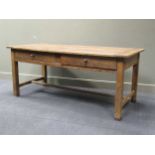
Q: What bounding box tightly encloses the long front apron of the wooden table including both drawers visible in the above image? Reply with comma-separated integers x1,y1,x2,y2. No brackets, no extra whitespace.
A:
13,51,117,71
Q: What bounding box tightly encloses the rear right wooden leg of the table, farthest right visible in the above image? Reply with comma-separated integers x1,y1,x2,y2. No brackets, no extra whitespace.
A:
131,56,139,102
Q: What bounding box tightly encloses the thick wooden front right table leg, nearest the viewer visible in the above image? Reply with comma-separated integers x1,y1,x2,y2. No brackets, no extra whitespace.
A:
114,62,124,120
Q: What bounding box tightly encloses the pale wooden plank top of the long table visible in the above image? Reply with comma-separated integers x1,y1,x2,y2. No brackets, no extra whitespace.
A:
8,44,144,58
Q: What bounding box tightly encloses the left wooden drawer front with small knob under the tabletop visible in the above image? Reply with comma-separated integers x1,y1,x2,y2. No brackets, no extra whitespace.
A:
15,52,61,66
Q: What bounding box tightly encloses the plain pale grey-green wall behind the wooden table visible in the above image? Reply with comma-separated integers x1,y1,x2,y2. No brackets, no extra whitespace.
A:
0,19,155,92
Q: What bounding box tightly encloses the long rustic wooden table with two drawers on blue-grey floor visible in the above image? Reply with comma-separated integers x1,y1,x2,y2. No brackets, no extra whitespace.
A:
8,44,144,120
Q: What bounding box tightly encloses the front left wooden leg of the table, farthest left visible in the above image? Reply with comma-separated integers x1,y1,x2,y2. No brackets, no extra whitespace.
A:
11,52,20,96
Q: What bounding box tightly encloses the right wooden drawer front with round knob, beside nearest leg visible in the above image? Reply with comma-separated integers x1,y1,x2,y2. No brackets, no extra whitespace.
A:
61,55,116,70
